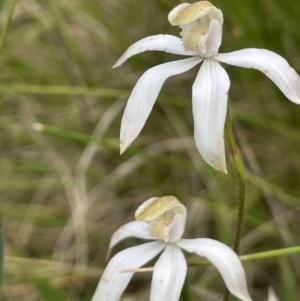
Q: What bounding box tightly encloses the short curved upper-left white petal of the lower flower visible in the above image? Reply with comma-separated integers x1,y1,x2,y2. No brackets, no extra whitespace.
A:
107,221,153,257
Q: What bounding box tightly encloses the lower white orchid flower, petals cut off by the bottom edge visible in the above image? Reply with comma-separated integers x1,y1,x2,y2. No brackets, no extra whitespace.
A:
92,196,252,301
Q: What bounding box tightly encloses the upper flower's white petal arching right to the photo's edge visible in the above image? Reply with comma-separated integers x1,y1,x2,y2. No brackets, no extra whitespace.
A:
214,48,300,104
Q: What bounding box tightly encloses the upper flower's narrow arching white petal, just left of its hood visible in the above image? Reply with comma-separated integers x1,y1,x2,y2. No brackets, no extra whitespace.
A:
113,34,198,68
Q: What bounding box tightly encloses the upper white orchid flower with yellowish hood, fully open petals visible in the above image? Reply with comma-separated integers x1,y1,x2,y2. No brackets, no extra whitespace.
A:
114,1,300,173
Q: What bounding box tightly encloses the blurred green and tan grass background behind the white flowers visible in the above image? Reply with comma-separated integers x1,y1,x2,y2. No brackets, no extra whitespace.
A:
0,0,300,301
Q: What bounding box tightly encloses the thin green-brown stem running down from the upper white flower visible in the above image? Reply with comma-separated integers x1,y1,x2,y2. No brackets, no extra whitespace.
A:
224,107,246,301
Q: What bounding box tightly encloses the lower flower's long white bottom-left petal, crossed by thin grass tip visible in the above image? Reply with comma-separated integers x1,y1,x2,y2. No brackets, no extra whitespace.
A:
92,241,165,301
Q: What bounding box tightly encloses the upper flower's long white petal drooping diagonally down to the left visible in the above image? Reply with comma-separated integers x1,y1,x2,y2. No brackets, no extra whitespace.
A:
120,57,202,154
